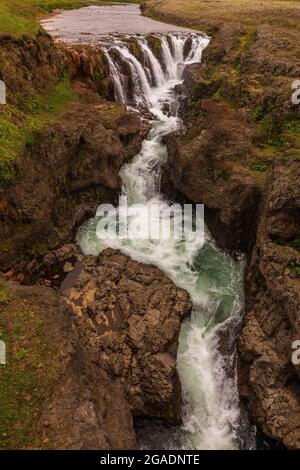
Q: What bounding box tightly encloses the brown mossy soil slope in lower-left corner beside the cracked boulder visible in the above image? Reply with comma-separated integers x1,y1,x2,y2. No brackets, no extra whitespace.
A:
0,279,135,450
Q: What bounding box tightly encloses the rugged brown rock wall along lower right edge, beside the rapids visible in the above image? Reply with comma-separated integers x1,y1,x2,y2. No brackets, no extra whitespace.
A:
239,163,300,449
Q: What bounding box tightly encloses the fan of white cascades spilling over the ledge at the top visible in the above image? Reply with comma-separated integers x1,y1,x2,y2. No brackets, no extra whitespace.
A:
104,33,208,109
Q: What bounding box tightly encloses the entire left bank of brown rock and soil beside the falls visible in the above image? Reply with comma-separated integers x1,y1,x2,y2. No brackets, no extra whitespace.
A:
0,20,191,449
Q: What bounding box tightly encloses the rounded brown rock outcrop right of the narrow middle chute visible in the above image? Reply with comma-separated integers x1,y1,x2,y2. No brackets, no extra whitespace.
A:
163,95,260,255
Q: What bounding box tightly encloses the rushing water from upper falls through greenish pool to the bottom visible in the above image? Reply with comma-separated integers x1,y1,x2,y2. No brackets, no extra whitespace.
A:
44,4,253,449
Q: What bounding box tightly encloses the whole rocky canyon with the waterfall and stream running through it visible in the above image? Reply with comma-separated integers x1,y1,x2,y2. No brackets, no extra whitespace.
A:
0,1,300,450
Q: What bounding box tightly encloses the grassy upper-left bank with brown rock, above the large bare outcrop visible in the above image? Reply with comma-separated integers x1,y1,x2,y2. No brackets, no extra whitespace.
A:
0,0,143,190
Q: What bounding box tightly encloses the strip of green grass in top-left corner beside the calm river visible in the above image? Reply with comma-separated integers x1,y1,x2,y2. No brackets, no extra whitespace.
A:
0,0,141,37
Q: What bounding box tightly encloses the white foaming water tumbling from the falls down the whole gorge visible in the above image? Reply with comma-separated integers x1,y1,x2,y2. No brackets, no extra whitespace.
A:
77,33,251,449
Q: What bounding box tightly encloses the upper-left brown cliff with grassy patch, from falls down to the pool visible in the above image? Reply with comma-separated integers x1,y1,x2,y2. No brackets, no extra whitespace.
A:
0,33,148,272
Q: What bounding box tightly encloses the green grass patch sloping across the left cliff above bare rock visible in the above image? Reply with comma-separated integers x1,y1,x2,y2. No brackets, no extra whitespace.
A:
0,75,78,190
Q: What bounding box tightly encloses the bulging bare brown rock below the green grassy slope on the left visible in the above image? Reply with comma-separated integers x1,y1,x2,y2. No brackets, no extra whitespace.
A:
0,91,147,270
